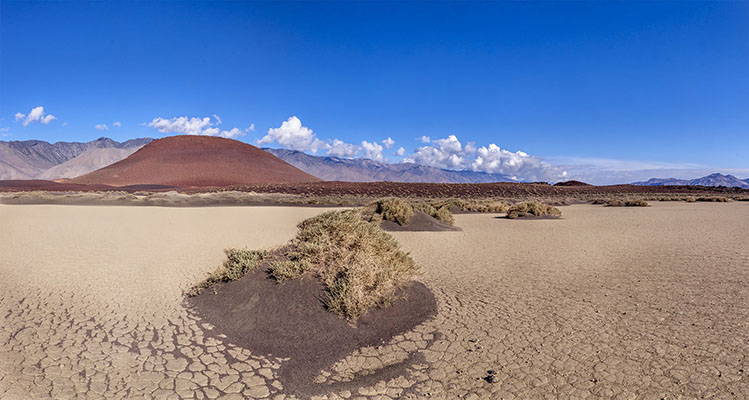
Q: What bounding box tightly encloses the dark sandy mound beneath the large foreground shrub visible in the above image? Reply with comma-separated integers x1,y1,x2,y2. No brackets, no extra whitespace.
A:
187,269,437,394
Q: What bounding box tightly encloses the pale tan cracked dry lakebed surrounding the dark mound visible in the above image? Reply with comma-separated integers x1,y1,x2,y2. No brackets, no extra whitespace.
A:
0,202,749,399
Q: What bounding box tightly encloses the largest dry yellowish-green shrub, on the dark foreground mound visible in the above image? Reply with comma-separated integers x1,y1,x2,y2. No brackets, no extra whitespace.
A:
284,210,418,320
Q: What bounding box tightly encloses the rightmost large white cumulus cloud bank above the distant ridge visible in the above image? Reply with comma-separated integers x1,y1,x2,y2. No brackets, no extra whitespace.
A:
403,135,567,181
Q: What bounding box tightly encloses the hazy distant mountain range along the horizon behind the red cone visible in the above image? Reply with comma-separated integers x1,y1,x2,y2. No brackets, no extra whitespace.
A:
0,137,749,189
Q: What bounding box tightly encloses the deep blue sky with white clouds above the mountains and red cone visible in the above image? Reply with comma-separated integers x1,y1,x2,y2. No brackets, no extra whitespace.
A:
0,0,749,183
